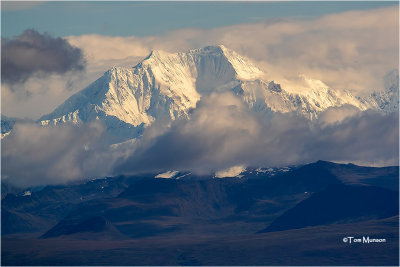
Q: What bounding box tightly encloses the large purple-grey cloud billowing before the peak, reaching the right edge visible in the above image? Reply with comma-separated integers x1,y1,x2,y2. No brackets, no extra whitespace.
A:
115,93,399,176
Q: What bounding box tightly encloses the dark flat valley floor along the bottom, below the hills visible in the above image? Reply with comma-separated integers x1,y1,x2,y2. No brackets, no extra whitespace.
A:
2,216,399,266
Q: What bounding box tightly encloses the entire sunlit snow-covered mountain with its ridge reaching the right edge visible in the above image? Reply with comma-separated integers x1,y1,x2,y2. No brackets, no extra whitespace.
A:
7,45,398,141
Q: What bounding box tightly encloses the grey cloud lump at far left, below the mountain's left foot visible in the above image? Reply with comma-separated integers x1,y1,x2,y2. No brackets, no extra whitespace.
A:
1,123,108,187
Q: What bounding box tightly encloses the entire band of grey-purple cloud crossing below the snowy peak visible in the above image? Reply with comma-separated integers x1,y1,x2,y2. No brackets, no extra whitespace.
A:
2,93,399,186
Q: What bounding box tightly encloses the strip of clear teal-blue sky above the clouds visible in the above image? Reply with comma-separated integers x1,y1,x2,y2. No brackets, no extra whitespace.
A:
1,1,398,37
